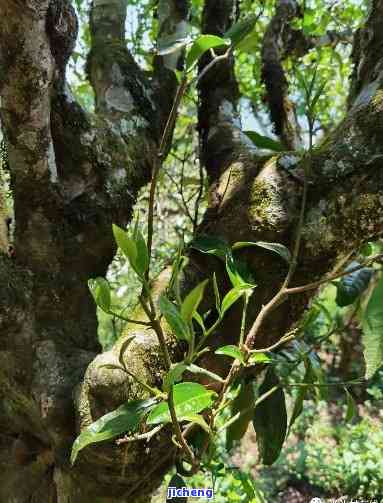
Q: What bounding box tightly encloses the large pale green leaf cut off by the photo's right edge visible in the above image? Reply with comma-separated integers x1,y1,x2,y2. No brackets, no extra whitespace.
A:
362,276,383,379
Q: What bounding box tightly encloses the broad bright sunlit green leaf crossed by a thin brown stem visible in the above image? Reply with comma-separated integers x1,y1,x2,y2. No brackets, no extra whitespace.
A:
146,382,216,424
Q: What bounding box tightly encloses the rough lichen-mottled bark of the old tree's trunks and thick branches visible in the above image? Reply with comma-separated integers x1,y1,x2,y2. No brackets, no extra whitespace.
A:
0,0,383,503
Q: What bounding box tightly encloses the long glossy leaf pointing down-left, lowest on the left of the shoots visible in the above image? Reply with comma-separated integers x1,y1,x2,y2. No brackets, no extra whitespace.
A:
71,398,157,465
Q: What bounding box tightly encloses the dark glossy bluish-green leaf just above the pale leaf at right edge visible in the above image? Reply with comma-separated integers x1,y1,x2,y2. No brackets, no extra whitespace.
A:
336,261,374,307
